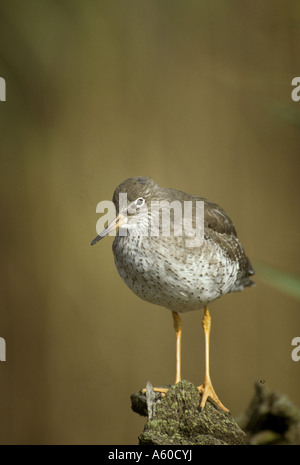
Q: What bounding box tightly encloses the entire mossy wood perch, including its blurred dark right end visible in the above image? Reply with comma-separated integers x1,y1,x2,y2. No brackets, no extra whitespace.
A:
131,381,300,445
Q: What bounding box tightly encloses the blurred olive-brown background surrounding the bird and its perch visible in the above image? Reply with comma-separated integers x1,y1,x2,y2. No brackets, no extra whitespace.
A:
0,0,300,444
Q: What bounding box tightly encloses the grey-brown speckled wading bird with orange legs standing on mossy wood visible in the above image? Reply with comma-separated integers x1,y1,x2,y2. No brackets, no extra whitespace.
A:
91,176,255,413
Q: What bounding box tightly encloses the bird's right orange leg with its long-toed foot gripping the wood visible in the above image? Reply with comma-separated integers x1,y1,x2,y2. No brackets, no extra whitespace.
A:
198,307,229,412
